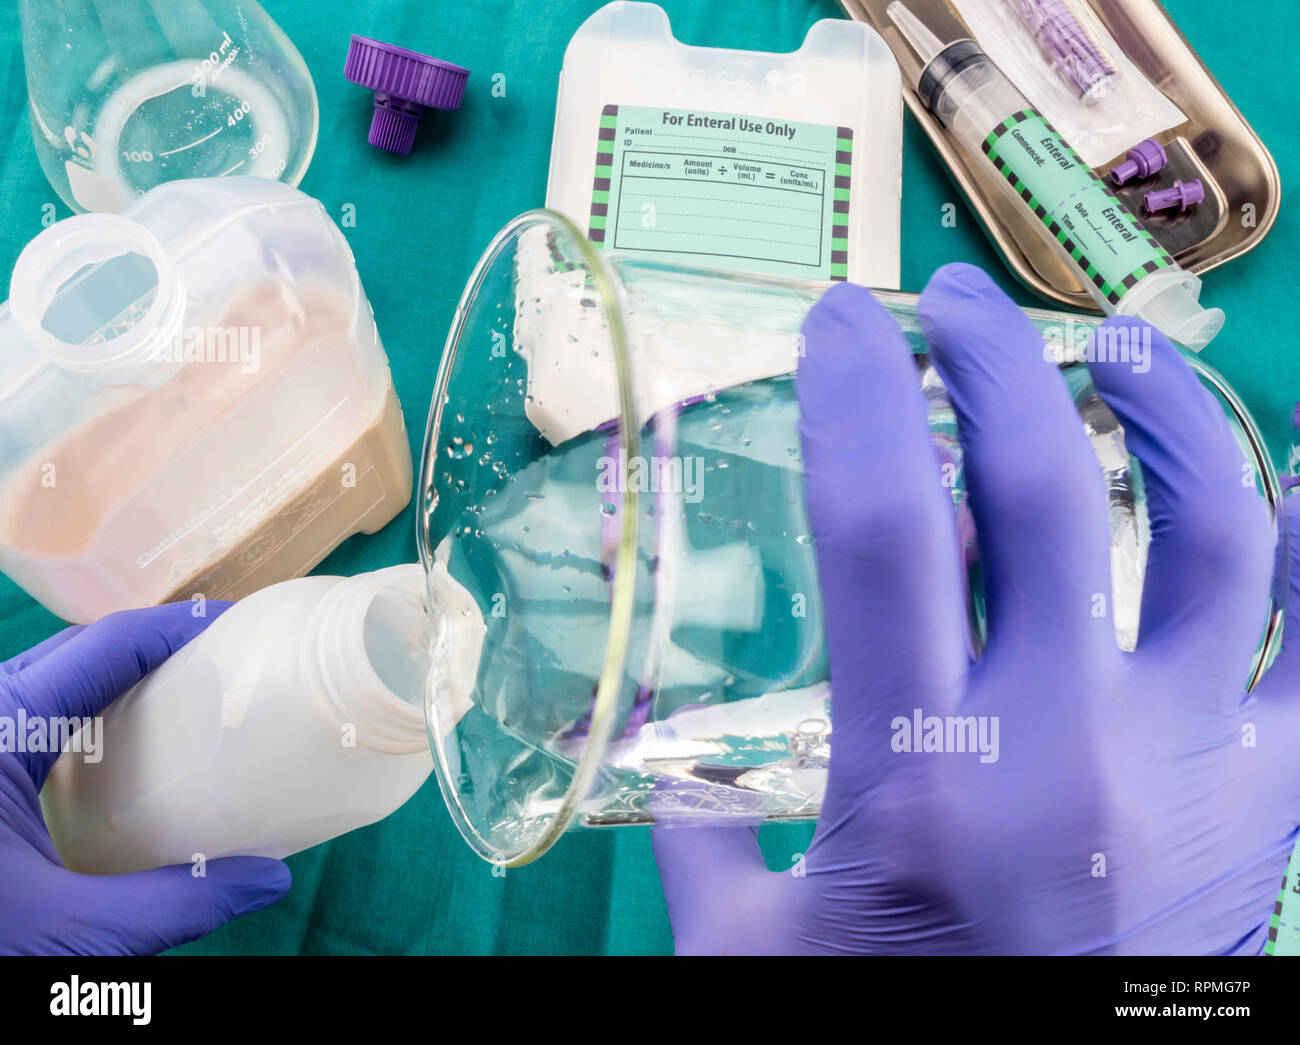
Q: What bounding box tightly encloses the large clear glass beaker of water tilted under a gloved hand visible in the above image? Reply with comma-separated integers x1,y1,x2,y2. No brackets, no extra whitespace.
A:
419,211,1284,866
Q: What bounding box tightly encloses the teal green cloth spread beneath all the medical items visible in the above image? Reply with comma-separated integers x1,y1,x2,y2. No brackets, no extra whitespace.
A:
0,0,1300,954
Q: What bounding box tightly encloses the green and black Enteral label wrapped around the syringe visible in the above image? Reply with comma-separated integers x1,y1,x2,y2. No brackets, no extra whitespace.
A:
983,109,1174,304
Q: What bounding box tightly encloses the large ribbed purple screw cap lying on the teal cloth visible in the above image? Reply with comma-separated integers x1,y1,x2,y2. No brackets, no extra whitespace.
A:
343,32,469,156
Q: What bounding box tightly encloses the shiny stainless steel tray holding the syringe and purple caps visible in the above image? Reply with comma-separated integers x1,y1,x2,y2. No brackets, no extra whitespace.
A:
840,0,1282,312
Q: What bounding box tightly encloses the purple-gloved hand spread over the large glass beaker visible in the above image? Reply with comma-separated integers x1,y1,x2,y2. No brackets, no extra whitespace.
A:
654,265,1300,954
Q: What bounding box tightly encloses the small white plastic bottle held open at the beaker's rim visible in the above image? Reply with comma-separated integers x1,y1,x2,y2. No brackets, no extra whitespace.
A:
42,564,484,875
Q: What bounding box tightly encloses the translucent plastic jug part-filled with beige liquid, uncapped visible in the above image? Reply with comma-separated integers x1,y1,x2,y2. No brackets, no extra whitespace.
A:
0,178,412,621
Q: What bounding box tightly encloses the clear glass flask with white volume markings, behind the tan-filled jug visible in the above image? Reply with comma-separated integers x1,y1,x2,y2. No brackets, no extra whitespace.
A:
18,0,320,213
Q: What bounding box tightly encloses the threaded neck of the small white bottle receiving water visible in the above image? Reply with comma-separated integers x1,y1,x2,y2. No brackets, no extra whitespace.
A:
303,564,432,754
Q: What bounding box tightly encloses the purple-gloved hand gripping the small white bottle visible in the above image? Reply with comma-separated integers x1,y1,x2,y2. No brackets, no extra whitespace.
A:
0,602,290,954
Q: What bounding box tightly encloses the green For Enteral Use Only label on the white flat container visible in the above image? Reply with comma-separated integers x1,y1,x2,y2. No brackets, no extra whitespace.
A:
588,105,853,279
